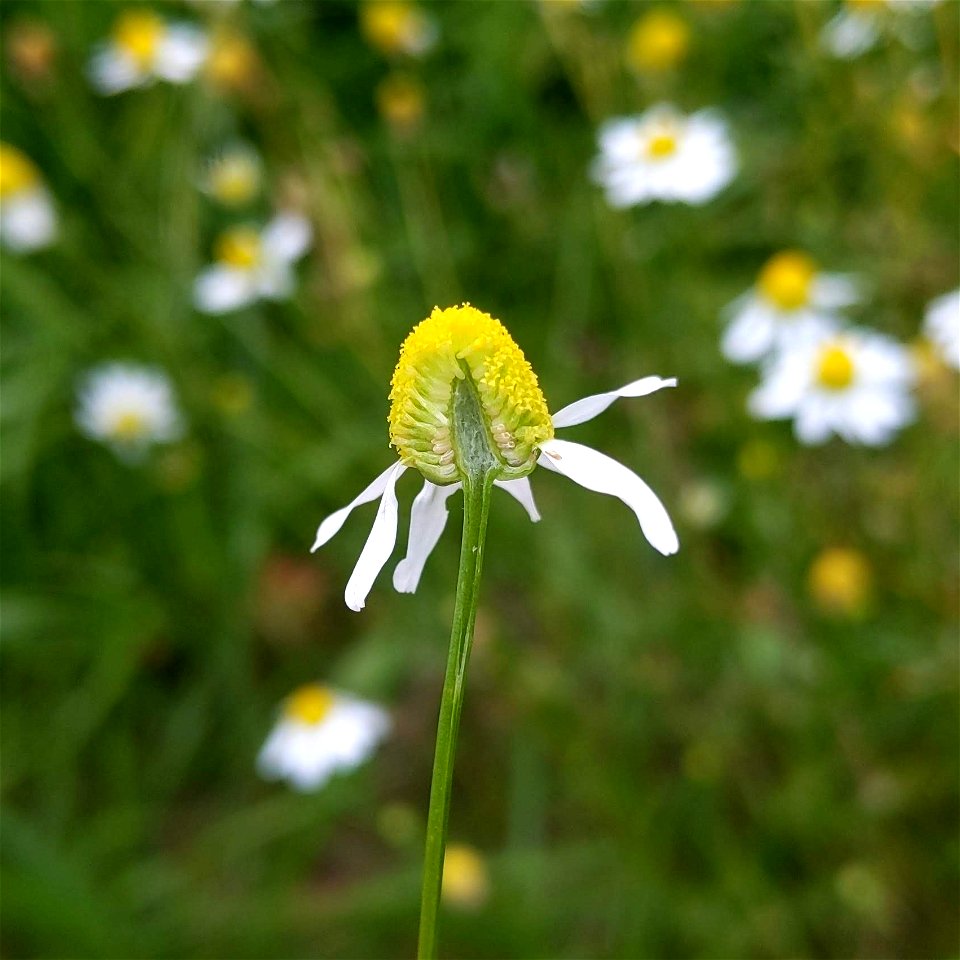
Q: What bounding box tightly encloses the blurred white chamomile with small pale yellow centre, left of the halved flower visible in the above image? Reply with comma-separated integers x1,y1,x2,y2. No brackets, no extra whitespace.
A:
76,363,183,459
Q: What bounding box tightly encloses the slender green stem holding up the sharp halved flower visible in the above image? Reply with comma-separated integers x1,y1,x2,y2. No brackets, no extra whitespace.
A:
417,469,496,960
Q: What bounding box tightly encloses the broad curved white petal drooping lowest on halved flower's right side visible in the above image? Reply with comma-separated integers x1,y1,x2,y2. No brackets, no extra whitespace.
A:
538,439,680,556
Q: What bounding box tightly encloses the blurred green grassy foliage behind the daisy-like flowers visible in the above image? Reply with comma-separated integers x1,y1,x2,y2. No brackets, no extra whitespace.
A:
0,0,958,957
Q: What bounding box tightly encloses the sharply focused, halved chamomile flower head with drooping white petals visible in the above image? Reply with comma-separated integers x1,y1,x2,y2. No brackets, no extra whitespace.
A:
313,304,679,610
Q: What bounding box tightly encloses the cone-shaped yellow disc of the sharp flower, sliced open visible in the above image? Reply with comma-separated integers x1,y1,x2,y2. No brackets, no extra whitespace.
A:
390,304,553,484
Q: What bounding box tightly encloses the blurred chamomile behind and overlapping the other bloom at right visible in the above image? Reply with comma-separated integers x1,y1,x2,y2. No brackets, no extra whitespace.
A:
720,250,860,363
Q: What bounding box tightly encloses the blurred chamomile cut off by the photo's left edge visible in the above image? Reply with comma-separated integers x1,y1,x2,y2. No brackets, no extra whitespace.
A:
0,143,57,253
